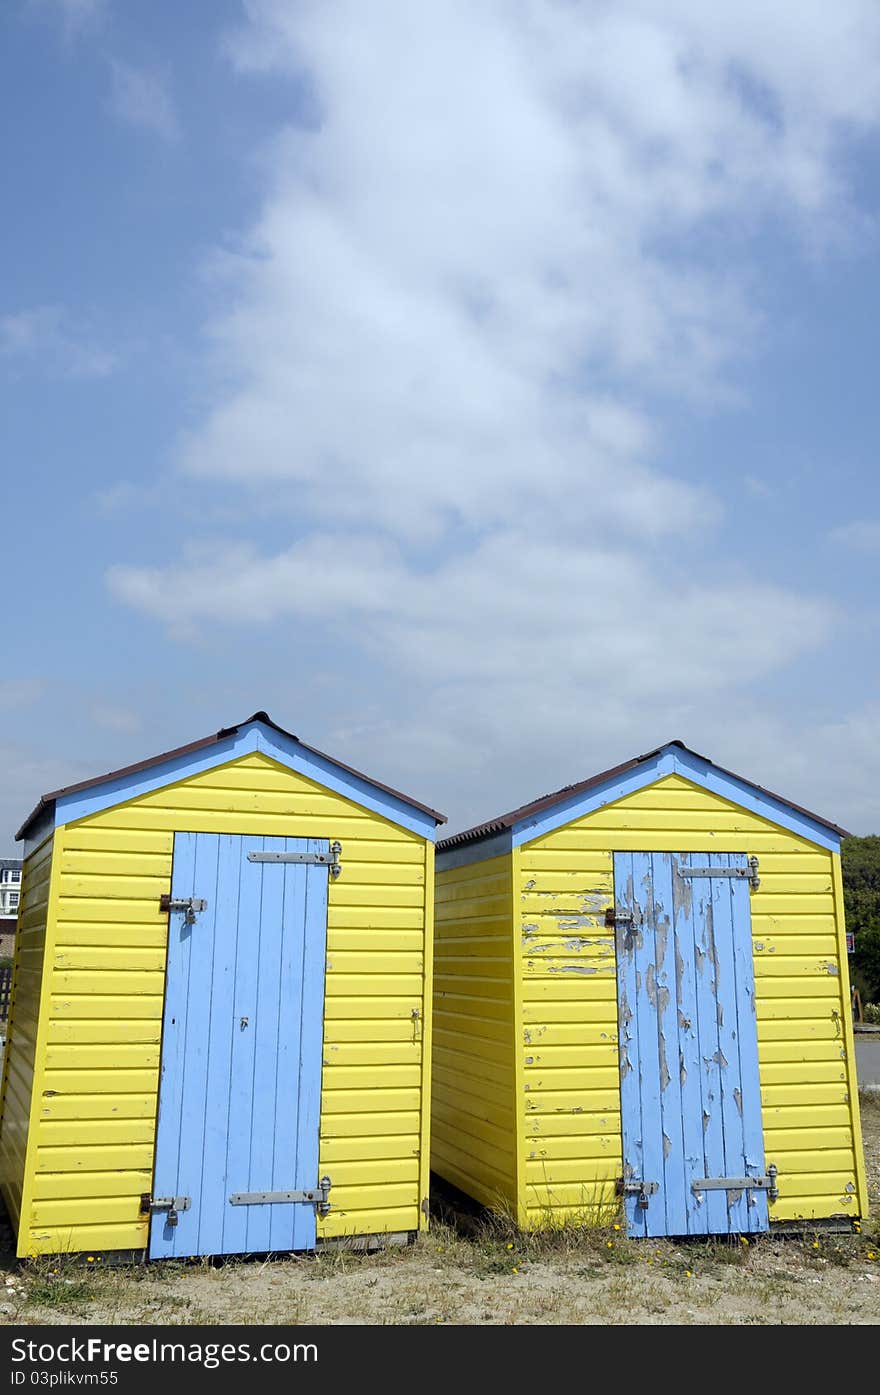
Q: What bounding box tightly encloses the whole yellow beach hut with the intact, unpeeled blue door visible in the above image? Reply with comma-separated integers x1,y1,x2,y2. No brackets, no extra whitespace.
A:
0,711,443,1258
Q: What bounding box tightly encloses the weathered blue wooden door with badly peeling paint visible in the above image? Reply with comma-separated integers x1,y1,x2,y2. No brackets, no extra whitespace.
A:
614,852,768,1236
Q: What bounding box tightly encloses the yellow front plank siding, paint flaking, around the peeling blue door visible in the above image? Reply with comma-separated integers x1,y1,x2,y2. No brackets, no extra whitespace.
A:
517,776,867,1223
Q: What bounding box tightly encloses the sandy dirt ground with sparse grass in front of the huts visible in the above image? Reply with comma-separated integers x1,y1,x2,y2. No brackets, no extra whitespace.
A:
0,1094,880,1325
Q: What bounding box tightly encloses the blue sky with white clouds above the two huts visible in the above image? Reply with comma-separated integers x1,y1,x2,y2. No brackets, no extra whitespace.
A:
0,0,880,854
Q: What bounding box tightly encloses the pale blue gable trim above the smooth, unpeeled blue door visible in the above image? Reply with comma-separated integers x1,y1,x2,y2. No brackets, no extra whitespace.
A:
54,721,437,843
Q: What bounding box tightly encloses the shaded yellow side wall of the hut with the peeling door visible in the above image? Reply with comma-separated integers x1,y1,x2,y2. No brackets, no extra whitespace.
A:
431,857,517,1205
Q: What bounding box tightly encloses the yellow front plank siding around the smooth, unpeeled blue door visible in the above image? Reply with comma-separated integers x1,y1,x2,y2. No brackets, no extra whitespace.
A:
22,753,434,1253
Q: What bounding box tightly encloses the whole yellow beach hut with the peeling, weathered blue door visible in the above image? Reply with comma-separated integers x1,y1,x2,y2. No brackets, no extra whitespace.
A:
432,741,867,1236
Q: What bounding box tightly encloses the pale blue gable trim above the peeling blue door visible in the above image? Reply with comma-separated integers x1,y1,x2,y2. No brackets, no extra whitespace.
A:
512,746,841,852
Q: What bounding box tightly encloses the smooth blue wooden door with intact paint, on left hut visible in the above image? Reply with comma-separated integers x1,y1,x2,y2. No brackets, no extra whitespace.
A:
149,833,328,1258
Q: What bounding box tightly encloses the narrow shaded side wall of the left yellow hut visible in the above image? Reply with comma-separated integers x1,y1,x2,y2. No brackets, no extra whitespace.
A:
0,837,53,1229
